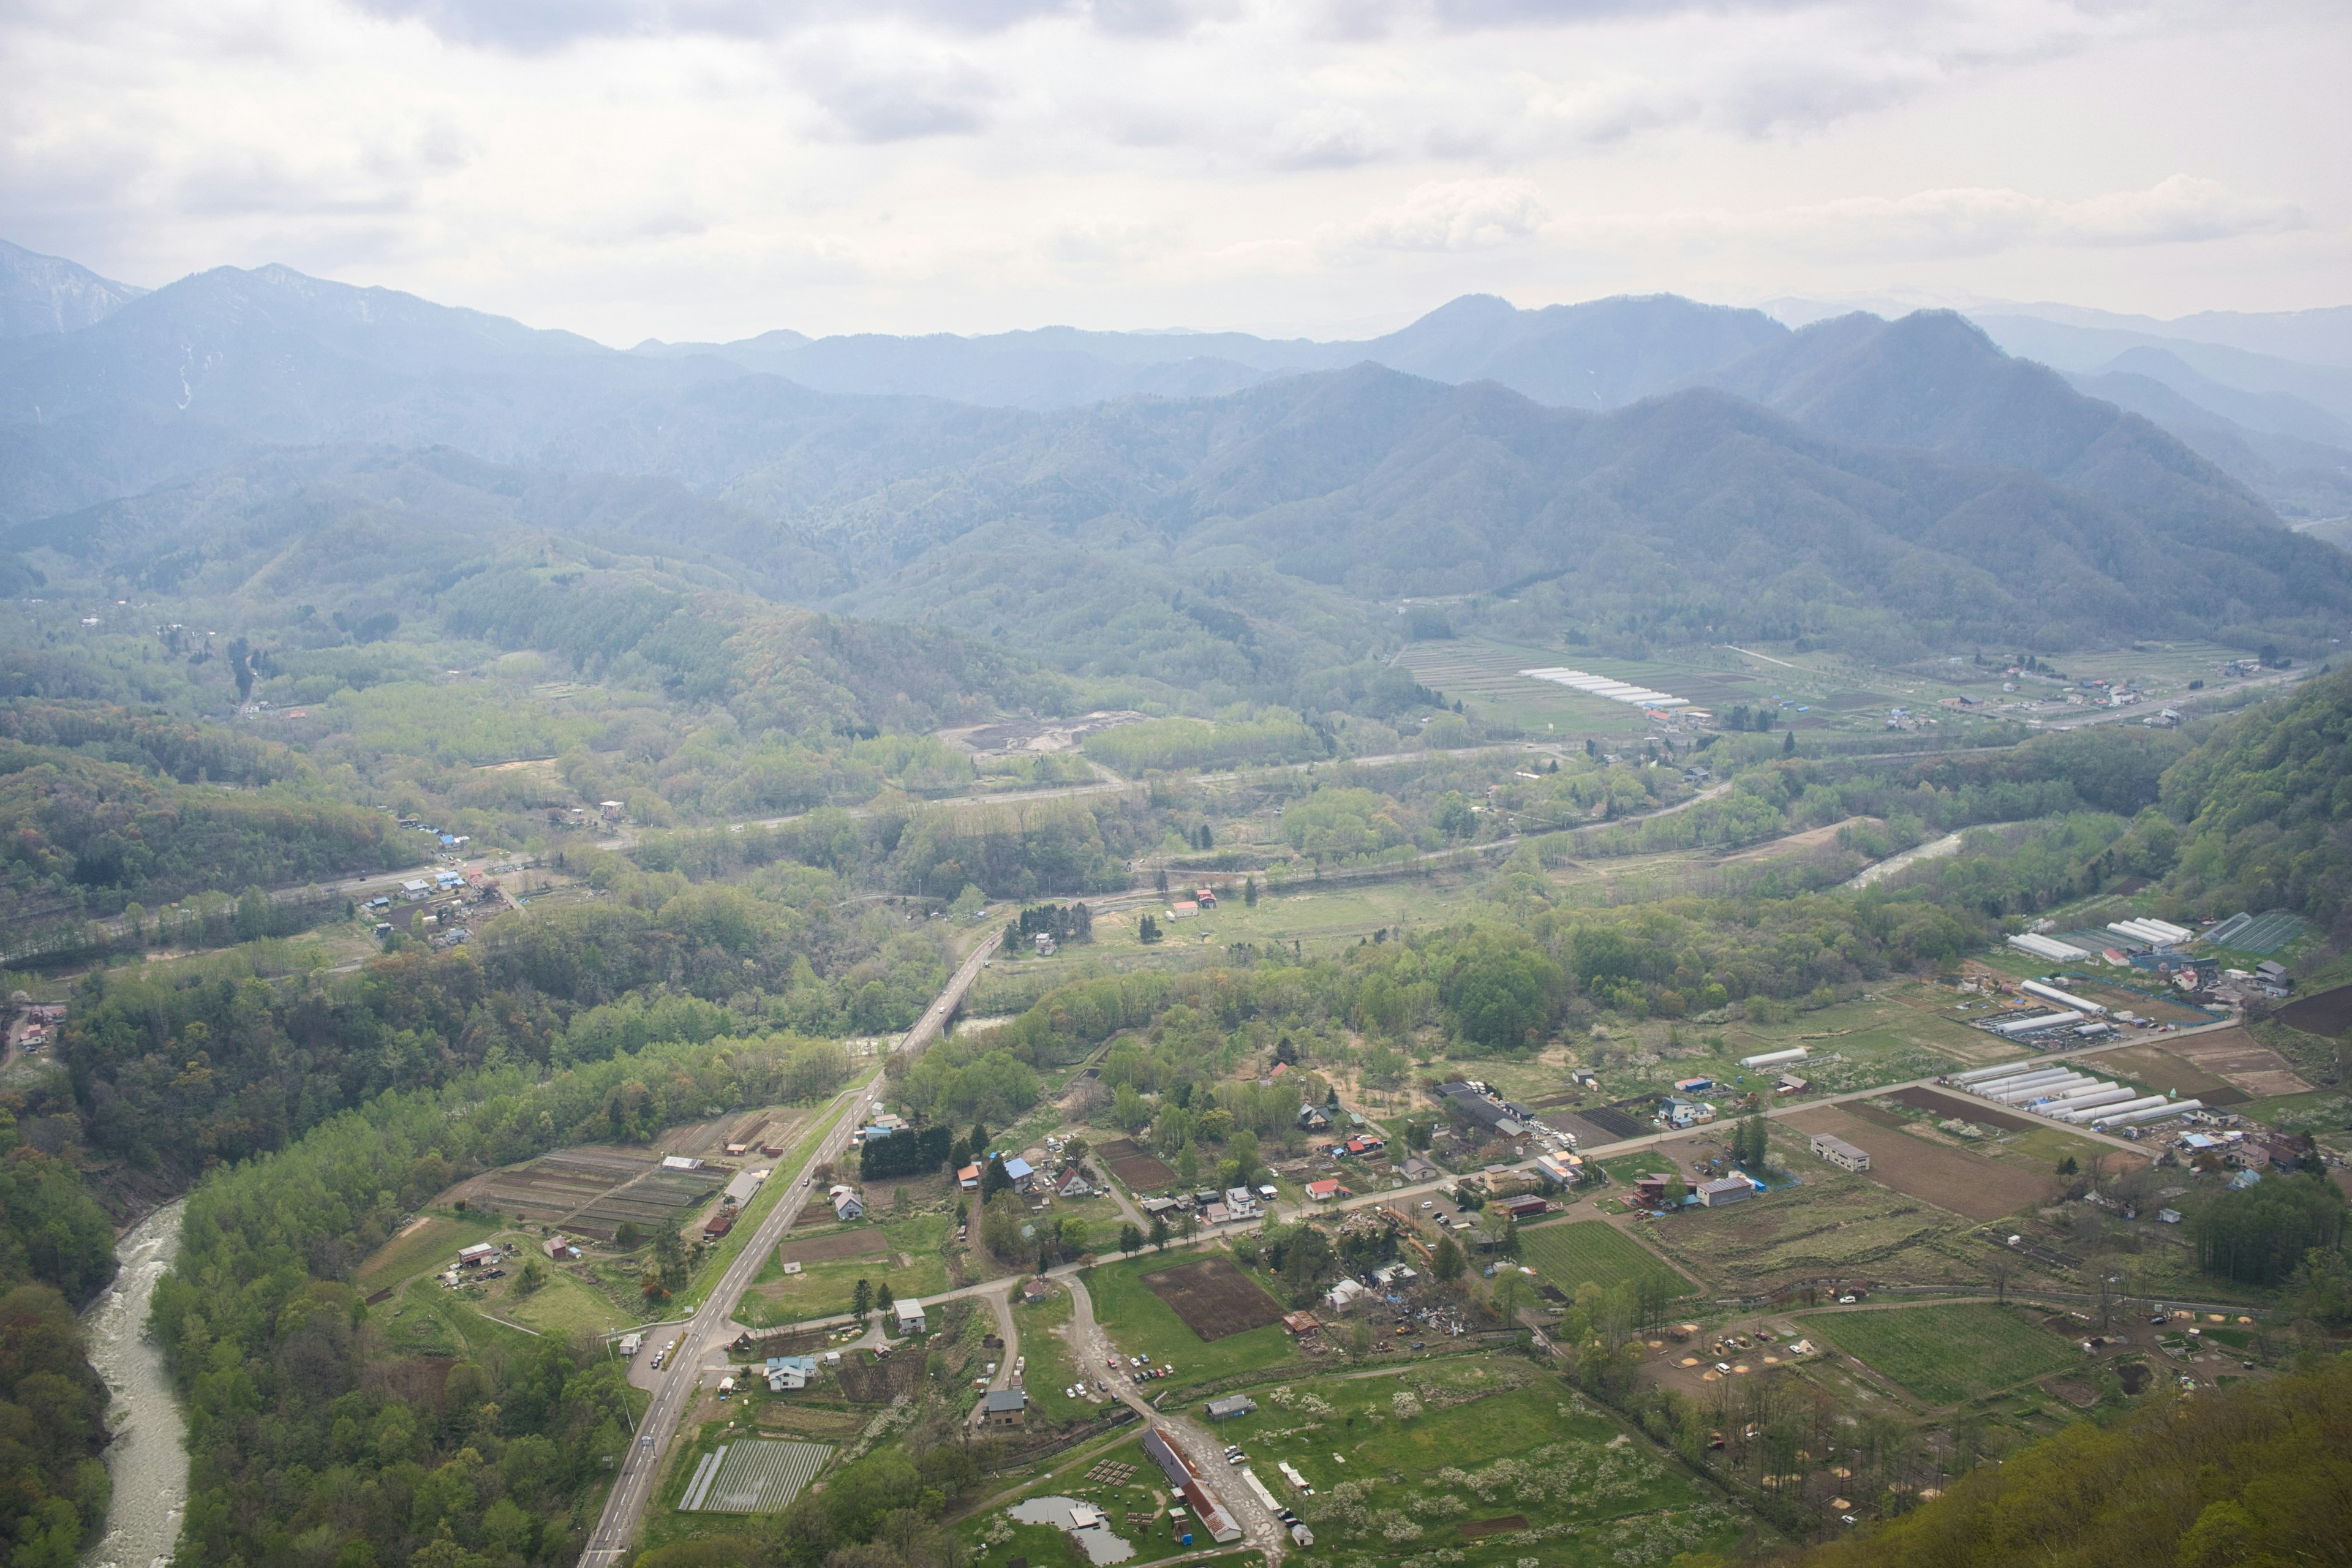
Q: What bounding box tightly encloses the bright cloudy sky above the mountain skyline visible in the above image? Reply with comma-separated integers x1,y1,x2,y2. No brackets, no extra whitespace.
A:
0,0,2352,345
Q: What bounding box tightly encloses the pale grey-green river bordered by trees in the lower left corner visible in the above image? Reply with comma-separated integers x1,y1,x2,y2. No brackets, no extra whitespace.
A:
82,1201,188,1568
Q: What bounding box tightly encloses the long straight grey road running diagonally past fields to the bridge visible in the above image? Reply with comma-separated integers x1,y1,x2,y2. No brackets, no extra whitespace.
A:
581,929,997,1568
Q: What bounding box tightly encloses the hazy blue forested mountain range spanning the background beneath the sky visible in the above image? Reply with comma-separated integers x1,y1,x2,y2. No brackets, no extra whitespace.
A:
0,242,2352,670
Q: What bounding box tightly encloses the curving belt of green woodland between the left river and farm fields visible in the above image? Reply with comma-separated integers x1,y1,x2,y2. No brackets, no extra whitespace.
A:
155,1037,846,1568
